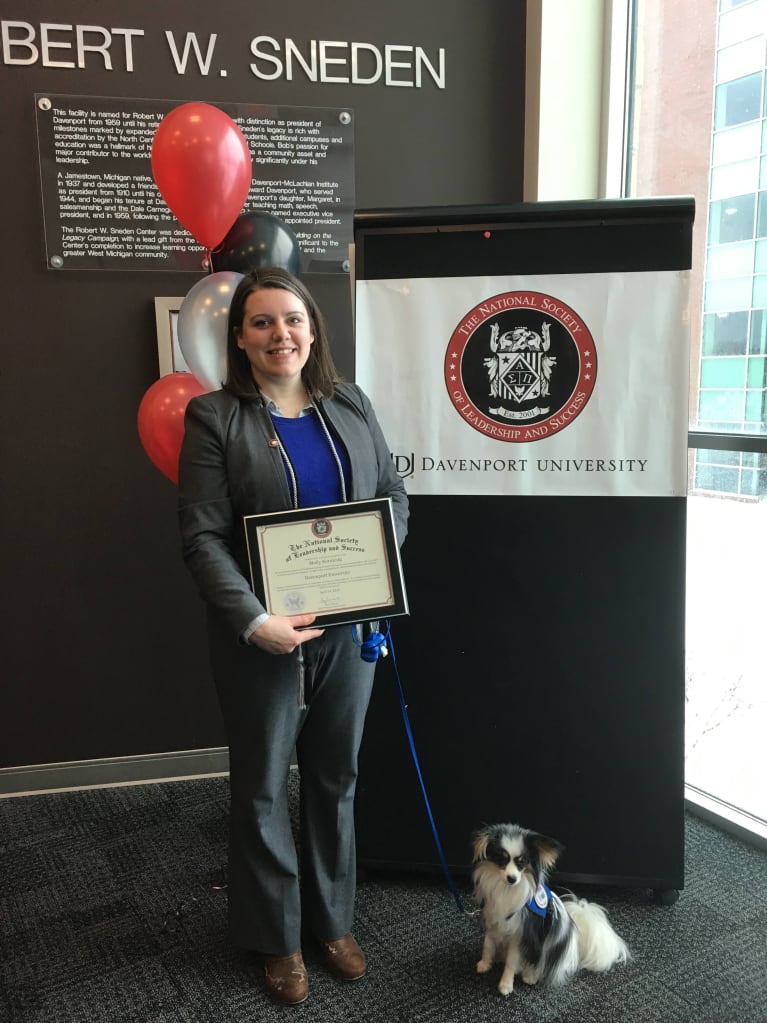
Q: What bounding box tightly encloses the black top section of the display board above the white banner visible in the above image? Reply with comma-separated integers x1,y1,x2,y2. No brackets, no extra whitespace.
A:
354,195,695,279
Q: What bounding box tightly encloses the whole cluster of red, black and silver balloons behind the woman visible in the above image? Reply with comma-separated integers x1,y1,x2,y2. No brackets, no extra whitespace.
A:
138,103,301,483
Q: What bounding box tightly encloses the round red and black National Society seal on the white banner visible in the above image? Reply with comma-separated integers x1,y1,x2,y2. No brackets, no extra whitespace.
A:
445,292,596,443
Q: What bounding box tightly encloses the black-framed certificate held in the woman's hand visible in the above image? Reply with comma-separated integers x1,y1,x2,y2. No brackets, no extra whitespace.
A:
243,497,408,628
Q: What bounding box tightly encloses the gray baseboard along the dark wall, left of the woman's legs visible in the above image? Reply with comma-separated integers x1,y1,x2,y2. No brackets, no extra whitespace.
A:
0,747,229,798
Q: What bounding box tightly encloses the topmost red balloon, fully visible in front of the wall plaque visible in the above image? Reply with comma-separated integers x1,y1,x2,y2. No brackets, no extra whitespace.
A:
151,103,253,249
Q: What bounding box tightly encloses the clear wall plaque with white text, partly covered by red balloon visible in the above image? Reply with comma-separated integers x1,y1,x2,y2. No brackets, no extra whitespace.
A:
35,93,354,273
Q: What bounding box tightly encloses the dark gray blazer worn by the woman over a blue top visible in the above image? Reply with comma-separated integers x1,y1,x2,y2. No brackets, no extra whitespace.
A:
178,384,408,641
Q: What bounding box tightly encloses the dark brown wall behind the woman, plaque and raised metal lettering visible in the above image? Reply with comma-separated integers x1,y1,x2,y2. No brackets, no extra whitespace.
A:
0,0,525,766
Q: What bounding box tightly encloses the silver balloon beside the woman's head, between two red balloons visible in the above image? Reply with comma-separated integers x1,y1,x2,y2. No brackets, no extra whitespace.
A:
177,270,243,391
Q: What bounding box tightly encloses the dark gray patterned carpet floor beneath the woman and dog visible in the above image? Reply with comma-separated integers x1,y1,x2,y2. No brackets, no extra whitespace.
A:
0,777,767,1023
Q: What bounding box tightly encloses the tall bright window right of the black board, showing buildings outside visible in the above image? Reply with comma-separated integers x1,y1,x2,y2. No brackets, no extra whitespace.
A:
627,0,767,837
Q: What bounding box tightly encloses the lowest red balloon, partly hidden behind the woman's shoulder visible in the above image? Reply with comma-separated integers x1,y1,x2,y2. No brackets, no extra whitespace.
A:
138,373,207,483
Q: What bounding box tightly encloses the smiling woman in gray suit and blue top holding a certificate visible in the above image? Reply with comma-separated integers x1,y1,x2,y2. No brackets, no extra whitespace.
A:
179,267,407,1005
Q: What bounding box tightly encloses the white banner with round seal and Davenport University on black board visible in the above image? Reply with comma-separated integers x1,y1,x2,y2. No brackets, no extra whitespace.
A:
356,270,689,497
